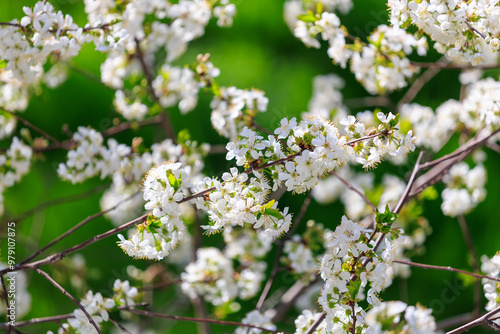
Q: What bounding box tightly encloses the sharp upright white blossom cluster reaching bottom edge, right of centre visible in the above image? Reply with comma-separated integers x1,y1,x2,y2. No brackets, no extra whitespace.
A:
318,216,398,333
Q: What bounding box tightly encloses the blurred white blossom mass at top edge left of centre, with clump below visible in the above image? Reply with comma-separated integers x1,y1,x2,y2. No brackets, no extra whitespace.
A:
85,0,236,90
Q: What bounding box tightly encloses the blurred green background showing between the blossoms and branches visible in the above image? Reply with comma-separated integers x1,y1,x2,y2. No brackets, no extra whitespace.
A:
0,0,500,333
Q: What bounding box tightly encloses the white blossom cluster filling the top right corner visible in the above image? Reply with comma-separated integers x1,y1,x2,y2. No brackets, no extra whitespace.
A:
388,0,500,65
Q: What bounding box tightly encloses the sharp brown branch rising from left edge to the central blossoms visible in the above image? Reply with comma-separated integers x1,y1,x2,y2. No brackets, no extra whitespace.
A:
0,214,148,276
